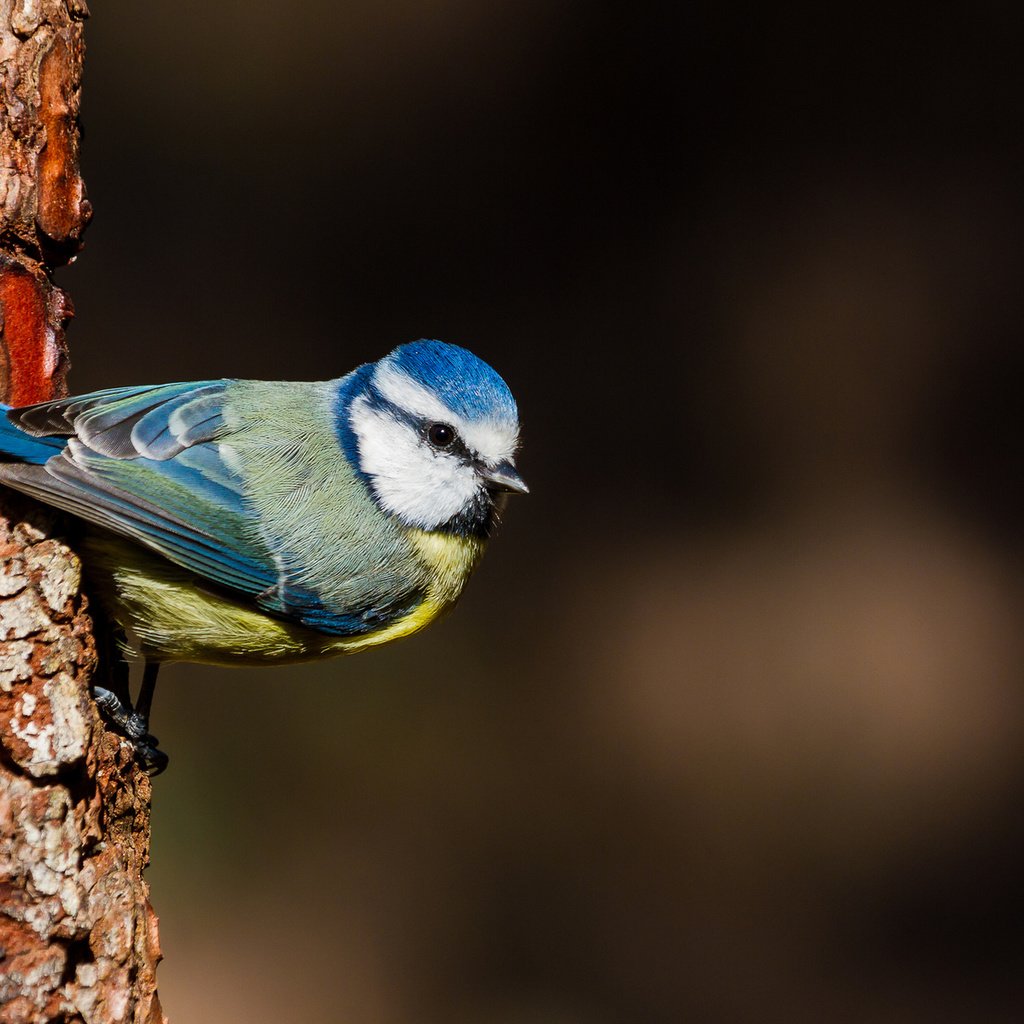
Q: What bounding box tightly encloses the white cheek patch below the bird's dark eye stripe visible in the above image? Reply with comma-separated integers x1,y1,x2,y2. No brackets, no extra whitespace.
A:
351,398,479,529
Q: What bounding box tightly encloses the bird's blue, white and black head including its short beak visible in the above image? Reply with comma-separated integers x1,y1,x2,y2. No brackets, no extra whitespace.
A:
339,341,527,537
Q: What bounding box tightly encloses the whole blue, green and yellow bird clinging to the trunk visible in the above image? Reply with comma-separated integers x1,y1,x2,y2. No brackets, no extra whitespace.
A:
0,339,528,773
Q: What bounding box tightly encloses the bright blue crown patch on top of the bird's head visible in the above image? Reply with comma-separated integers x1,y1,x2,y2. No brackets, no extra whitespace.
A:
384,340,519,424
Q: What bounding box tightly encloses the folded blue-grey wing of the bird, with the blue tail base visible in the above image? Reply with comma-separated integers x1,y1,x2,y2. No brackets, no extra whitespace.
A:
0,380,395,635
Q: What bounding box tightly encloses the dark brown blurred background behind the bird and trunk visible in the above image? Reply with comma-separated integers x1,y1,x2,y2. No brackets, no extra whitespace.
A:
60,0,1024,1024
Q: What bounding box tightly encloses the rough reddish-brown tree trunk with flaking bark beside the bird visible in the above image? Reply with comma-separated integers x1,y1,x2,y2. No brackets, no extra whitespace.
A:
0,0,164,1024
